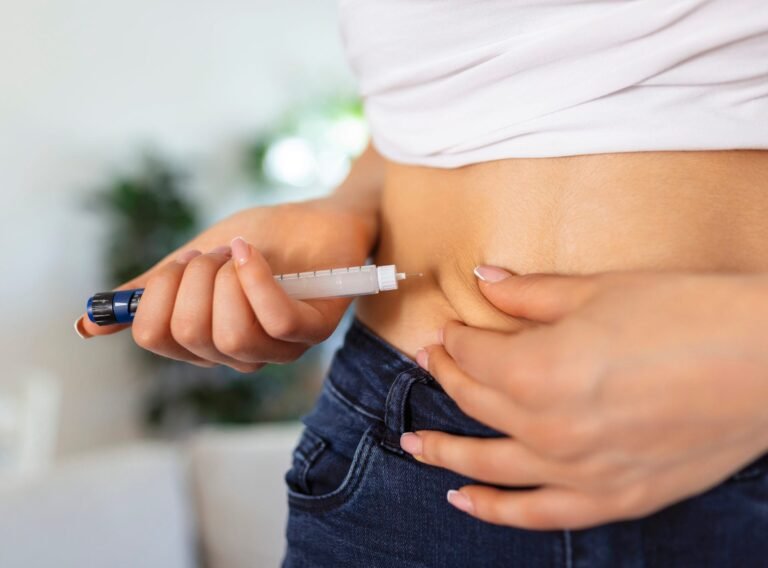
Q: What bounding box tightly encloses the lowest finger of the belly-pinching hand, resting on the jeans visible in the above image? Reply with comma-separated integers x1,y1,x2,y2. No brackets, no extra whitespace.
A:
448,485,617,530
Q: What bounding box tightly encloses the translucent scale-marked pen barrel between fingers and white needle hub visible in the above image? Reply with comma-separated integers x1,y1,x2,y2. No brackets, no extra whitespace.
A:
275,265,379,300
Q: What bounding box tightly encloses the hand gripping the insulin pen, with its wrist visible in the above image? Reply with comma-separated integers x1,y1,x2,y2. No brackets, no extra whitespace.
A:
76,197,377,372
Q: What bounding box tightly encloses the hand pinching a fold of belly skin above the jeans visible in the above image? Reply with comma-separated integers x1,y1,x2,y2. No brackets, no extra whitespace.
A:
401,267,768,529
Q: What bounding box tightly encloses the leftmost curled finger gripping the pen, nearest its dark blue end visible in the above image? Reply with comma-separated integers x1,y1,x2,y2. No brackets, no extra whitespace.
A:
132,251,213,366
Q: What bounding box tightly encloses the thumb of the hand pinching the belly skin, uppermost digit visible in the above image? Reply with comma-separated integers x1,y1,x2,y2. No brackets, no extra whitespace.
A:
474,266,596,323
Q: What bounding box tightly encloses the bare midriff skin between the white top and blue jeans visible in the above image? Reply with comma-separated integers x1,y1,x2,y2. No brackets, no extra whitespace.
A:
357,151,768,356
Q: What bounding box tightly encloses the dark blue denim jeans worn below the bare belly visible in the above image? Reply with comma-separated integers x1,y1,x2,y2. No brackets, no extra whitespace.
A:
283,321,768,568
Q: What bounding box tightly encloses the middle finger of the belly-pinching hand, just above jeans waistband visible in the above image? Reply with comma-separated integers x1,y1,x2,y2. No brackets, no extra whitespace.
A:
417,345,521,434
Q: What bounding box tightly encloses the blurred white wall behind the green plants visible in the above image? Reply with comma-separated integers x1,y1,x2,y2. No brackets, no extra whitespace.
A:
0,0,354,455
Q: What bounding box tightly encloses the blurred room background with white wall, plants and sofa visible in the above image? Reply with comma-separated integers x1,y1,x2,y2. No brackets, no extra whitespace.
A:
0,0,367,568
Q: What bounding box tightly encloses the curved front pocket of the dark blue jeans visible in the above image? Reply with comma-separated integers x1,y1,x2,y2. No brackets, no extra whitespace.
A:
285,426,376,510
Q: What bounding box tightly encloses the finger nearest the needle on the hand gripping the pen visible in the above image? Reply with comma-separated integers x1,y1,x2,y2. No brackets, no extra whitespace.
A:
232,237,348,343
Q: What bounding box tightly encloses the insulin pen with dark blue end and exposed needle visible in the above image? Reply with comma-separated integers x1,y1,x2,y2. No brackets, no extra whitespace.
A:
86,264,421,325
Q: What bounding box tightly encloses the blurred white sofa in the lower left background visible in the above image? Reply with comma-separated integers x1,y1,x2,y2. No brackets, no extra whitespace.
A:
0,424,299,568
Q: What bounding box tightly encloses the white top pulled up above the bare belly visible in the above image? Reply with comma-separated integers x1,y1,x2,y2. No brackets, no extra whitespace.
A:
340,0,768,168
